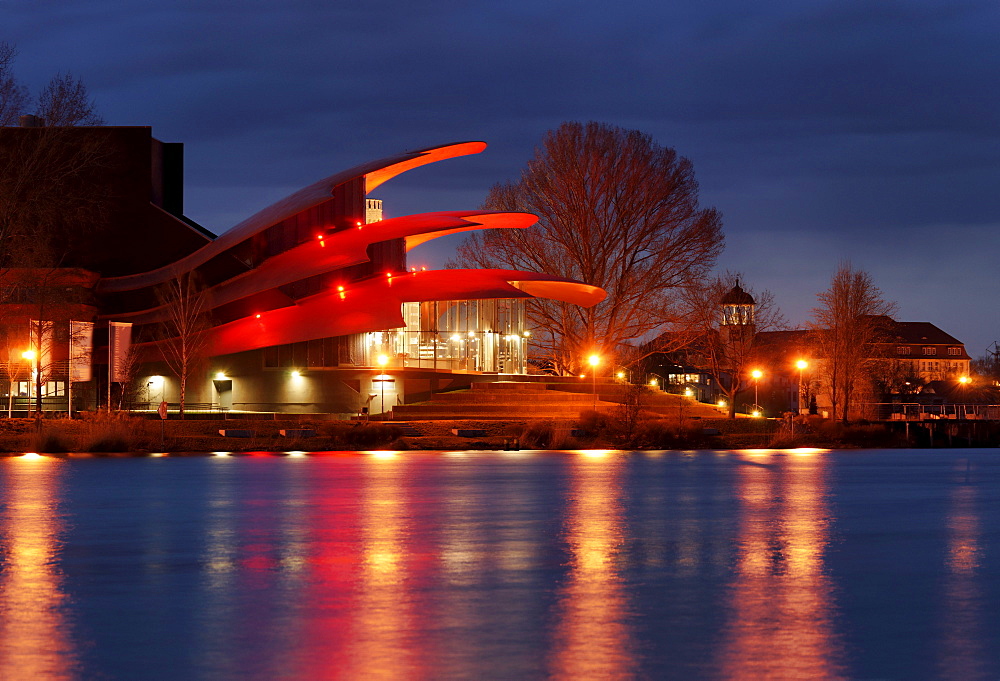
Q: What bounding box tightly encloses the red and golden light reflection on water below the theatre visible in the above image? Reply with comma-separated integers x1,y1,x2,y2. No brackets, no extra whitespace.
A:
300,453,434,679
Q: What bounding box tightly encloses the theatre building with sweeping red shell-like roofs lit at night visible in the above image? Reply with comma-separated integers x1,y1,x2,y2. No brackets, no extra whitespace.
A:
0,121,605,416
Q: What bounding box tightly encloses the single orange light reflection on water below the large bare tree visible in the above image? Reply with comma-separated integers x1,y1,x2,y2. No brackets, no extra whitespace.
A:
550,452,635,680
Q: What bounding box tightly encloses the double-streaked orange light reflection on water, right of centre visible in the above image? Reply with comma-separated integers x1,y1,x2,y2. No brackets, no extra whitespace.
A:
721,452,845,679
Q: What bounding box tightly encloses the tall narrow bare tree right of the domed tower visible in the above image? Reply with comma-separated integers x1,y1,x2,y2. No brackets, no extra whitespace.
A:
812,262,896,423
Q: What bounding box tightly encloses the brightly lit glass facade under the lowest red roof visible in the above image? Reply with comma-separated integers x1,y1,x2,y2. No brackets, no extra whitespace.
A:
364,299,528,374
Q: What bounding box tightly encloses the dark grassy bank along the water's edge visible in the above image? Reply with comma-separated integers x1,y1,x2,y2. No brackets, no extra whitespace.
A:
0,413,984,453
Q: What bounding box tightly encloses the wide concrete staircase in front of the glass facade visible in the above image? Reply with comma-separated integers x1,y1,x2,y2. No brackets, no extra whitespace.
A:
392,381,616,421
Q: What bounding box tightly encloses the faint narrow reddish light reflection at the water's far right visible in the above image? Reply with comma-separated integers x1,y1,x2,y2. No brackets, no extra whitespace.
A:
938,464,995,679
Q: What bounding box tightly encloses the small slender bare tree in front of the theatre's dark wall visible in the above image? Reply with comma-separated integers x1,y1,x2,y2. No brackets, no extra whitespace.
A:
157,273,211,419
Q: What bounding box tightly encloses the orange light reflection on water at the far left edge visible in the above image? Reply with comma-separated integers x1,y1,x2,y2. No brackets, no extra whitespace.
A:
0,456,77,679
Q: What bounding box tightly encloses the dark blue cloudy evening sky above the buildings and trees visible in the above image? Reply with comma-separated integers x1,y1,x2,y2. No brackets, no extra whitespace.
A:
0,0,1000,356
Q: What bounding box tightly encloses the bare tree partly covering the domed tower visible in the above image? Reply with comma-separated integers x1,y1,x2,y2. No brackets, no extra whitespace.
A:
683,272,786,418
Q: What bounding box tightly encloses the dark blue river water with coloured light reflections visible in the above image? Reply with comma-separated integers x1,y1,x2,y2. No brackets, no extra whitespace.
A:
0,449,1000,680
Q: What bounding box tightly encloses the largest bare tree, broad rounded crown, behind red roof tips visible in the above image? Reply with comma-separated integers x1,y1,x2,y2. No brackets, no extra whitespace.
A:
456,123,724,373
